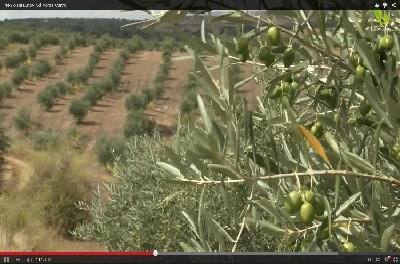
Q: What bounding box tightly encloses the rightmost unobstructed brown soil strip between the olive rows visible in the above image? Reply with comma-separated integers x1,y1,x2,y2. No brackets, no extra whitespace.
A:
145,53,193,133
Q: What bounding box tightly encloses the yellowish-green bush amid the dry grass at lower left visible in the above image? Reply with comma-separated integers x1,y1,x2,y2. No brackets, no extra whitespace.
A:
27,153,90,238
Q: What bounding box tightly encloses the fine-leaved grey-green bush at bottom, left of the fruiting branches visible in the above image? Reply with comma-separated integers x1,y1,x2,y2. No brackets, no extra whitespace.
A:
73,136,191,252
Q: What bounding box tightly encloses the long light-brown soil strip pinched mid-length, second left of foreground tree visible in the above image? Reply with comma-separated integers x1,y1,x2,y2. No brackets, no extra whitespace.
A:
79,51,161,138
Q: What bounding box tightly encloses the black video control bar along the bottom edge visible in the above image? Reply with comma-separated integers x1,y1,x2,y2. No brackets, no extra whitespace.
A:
0,253,400,264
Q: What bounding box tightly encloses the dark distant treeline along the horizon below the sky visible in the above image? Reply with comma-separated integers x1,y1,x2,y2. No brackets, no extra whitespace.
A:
0,18,169,40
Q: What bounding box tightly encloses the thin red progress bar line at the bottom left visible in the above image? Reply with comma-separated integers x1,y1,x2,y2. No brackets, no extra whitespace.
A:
0,251,154,256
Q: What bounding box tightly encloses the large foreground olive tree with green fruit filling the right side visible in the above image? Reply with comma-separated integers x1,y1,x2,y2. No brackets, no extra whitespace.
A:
76,10,400,252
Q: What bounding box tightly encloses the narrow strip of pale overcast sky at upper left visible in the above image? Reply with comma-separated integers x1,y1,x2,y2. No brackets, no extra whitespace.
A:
0,10,151,20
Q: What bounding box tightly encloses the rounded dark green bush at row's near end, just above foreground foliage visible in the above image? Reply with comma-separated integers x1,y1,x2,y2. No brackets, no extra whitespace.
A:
124,110,155,138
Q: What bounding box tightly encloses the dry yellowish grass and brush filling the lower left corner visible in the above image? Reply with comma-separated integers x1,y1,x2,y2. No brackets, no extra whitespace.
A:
0,135,105,251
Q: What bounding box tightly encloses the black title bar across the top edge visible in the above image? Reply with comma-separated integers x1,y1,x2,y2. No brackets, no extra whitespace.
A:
0,0,394,10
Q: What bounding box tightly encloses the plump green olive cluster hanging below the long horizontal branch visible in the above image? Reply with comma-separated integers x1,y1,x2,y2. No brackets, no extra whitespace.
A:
285,190,325,225
